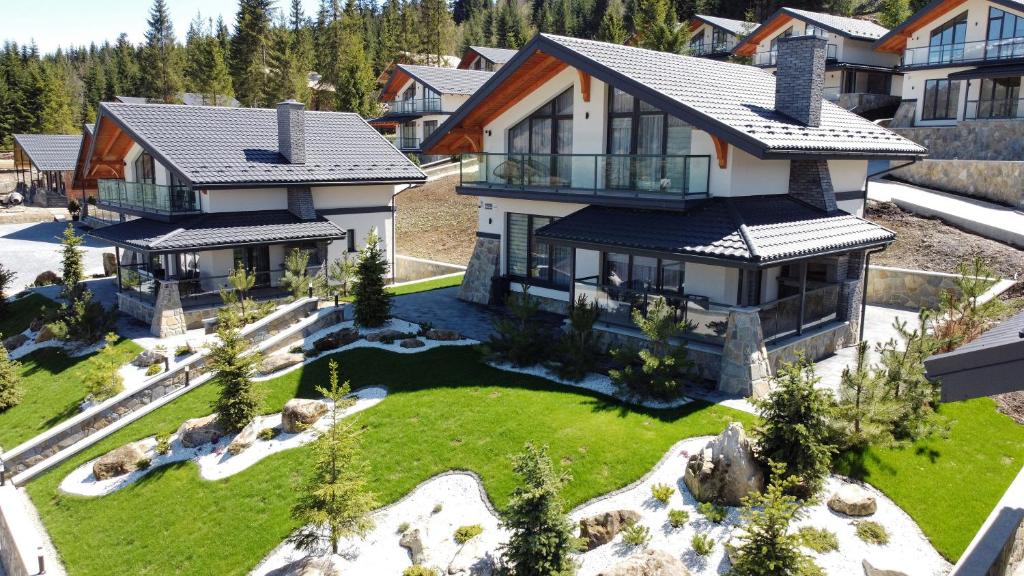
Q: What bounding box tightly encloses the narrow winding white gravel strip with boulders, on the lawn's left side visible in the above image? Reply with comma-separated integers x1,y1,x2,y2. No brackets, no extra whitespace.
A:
60,386,387,496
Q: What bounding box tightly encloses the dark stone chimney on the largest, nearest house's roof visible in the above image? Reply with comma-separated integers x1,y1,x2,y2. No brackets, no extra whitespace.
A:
775,36,828,128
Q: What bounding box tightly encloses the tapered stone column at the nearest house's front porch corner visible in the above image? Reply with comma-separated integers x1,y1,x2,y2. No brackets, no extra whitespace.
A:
718,307,771,398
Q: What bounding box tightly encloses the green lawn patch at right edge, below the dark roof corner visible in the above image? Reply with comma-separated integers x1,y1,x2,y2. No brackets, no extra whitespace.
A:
838,398,1024,562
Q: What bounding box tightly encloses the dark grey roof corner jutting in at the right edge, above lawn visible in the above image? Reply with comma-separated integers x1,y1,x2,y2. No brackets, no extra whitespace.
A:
925,313,1024,402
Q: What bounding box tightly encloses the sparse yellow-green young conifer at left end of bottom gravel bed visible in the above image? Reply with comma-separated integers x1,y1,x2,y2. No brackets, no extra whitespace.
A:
289,360,377,553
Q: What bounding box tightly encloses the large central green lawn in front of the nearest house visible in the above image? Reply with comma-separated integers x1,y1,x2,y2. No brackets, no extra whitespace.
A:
28,347,751,575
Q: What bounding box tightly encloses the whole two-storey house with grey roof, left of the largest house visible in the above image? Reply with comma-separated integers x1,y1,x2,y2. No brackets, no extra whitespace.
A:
85,100,425,336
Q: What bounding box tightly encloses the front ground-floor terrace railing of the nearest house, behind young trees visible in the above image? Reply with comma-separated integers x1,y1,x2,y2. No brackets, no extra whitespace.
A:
575,276,734,344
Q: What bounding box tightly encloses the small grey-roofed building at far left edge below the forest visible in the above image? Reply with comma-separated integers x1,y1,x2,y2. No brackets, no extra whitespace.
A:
14,134,82,207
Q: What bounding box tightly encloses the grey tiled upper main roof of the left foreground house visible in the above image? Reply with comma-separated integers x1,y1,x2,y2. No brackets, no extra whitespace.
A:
90,102,426,188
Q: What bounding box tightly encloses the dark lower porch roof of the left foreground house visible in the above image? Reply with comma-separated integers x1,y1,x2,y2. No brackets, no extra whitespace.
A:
89,210,345,252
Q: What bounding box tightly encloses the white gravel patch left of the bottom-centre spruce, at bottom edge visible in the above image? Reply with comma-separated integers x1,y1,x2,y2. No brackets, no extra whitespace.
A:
251,472,508,576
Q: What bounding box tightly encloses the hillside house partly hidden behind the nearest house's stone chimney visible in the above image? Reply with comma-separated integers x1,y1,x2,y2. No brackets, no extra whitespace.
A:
733,8,902,119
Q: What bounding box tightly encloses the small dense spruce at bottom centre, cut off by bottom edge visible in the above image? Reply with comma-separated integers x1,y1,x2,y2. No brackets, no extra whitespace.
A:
502,444,575,576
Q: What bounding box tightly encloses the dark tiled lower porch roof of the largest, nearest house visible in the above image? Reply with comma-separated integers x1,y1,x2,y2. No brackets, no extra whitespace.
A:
537,195,896,266
